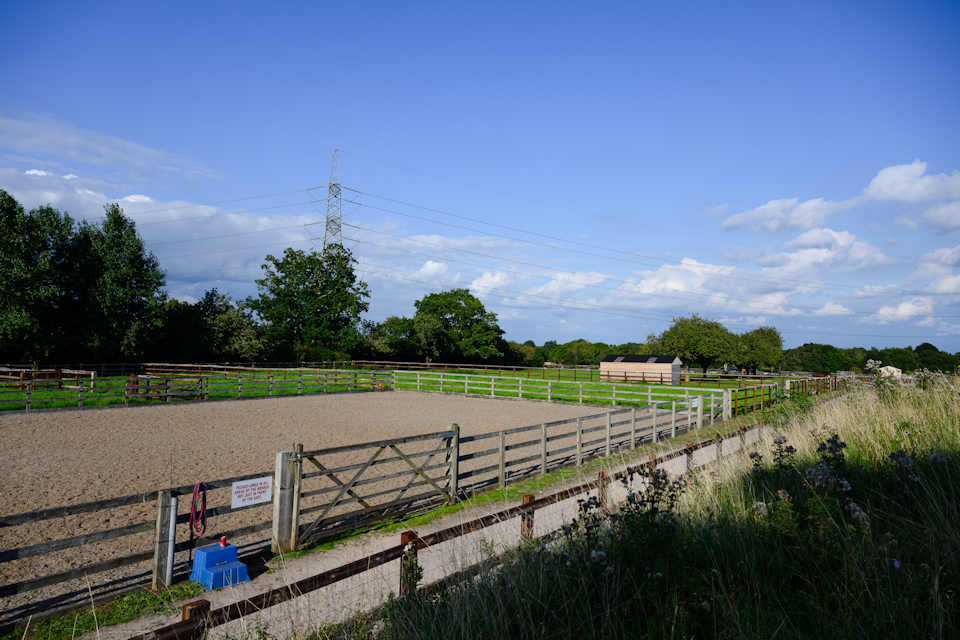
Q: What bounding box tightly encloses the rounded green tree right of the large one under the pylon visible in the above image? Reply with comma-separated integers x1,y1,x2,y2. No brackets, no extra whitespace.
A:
413,289,506,362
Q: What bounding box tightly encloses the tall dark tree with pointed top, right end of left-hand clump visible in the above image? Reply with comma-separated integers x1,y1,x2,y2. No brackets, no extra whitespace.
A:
73,203,164,361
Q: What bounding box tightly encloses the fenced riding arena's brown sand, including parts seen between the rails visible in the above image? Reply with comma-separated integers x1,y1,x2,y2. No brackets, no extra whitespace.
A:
0,391,604,623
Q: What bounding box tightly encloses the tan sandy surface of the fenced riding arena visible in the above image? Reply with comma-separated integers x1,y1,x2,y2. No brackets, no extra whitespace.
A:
0,391,602,618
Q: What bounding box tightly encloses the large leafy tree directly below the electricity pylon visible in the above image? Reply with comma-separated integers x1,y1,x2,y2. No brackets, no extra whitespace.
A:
246,244,370,362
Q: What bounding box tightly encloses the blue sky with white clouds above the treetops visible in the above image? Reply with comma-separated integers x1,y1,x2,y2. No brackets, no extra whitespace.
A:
0,2,960,351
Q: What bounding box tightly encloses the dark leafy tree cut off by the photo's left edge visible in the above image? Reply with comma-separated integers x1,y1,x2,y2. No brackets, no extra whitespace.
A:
0,190,74,363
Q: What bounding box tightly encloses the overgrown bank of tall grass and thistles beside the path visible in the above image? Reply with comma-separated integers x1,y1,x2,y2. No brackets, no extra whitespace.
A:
318,377,960,640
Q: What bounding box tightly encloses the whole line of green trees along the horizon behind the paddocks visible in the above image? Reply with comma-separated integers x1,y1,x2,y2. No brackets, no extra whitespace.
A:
0,190,958,372
